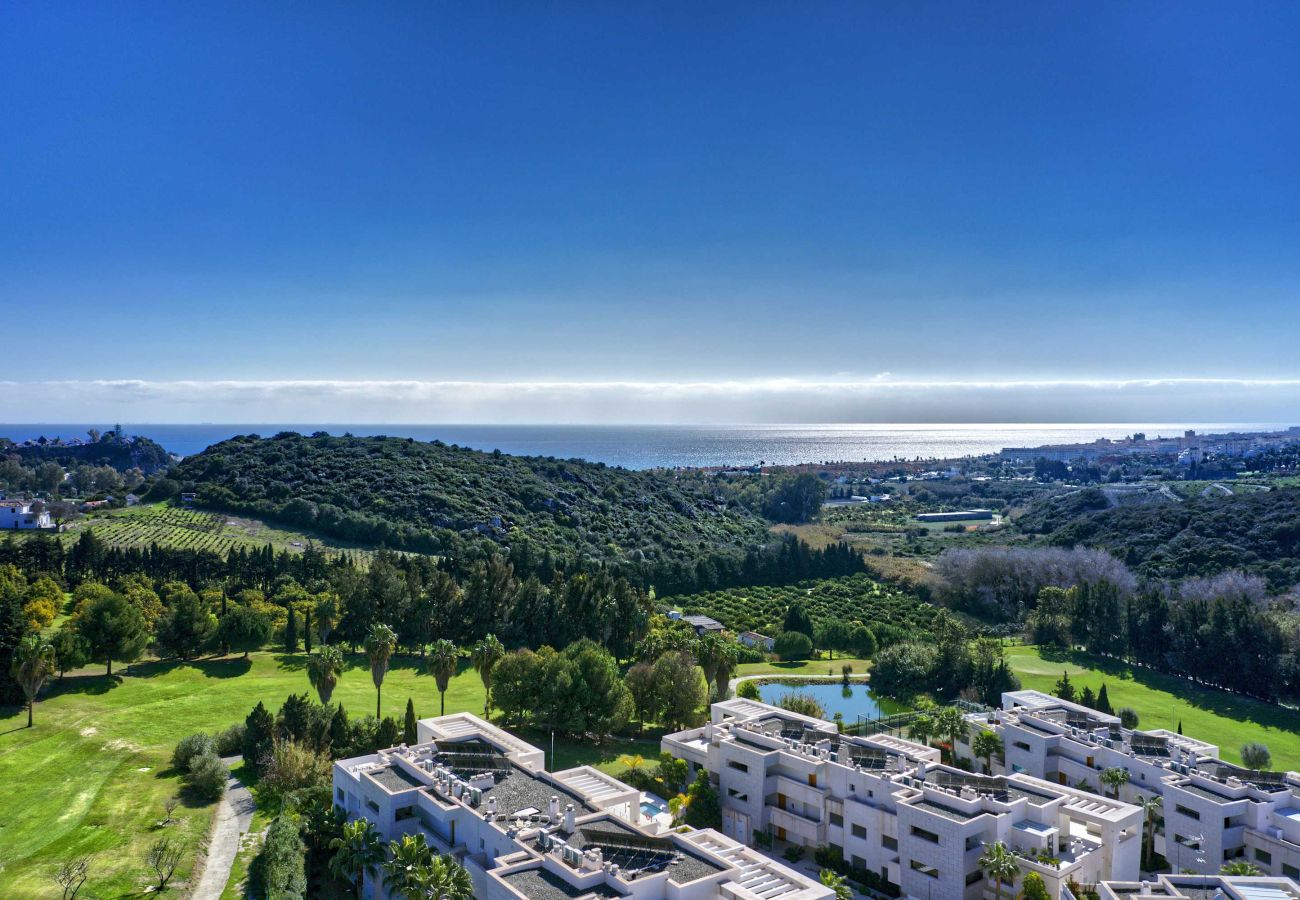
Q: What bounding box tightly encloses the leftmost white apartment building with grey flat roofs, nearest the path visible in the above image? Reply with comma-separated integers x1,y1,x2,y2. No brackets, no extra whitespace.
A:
334,713,835,900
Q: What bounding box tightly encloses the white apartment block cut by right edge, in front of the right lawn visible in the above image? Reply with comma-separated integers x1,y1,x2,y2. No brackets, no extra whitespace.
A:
958,691,1300,878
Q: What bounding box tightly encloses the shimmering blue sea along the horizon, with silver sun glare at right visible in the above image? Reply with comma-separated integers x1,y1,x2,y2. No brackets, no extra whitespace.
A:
0,423,1292,468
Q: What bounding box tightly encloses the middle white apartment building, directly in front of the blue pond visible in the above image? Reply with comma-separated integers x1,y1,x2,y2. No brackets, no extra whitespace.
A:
663,698,1143,900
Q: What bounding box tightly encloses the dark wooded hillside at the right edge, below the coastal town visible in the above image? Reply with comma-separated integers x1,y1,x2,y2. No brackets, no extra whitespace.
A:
1019,489,1300,590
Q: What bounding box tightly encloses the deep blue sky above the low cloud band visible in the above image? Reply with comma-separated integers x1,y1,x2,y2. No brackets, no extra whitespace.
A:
0,3,1300,420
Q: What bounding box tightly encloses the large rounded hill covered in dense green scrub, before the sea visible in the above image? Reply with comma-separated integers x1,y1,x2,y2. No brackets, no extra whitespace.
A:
170,433,766,566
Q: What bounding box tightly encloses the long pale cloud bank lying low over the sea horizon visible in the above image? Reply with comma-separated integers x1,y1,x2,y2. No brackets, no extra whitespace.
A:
0,376,1300,424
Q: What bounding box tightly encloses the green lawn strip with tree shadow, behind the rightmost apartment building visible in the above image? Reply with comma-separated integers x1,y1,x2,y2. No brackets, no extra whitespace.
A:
1008,646,1300,770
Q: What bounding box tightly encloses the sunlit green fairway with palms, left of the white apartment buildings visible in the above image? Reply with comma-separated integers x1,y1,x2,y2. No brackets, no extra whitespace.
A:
0,653,658,897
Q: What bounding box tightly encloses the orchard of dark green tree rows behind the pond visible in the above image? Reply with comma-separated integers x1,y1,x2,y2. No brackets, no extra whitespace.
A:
672,575,935,645
